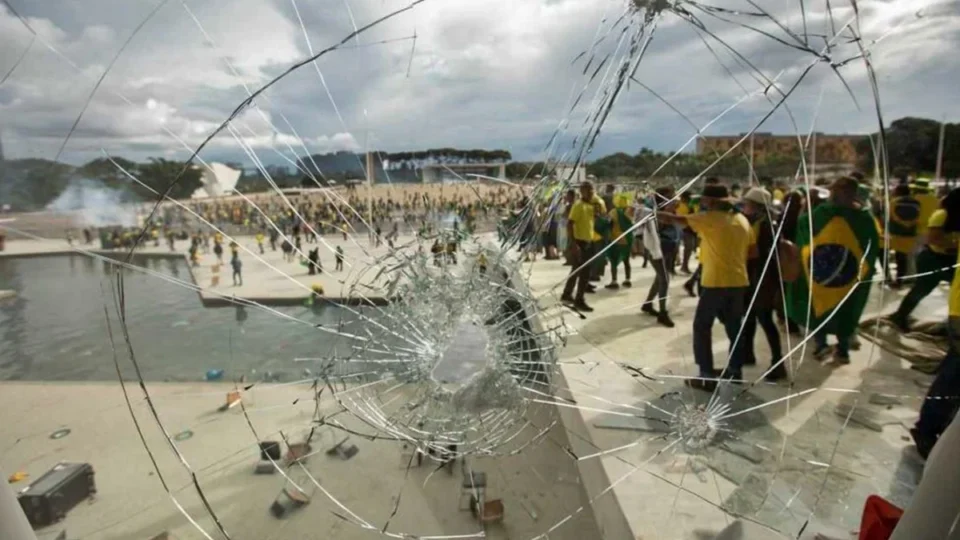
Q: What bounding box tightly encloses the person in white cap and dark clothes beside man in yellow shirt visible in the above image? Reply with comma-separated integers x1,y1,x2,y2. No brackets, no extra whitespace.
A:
740,187,787,381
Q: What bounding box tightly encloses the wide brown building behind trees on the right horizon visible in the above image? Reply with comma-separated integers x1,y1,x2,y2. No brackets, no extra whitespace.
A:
697,133,865,169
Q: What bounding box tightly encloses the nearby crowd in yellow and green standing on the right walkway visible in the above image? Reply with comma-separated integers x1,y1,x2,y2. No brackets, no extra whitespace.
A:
542,173,960,457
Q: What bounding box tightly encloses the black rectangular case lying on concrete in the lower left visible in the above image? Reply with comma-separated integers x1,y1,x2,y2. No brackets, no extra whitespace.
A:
17,463,97,527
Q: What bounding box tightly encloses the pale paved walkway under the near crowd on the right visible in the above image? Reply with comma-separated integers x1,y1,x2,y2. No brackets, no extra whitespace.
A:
527,254,946,539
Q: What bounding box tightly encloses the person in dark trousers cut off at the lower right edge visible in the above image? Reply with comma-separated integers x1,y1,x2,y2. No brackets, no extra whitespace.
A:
910,237,960,459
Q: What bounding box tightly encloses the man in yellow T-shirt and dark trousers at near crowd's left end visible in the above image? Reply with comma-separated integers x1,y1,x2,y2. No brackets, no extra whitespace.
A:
560,182,604,312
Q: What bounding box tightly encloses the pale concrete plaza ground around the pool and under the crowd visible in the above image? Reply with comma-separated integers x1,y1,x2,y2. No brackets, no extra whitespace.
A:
0,234,946,539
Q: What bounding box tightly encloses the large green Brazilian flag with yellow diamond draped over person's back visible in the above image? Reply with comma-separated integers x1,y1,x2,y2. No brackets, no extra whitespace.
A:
787,203,882,336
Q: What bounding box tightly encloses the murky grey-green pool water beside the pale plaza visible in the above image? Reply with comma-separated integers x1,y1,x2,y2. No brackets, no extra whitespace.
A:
0,255,390,381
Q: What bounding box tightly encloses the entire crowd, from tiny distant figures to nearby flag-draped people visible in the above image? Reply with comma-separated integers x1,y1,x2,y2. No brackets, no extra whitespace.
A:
54,173,960,462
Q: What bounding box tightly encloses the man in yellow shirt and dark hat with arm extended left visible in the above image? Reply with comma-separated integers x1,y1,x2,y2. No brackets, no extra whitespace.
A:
667,184,756,392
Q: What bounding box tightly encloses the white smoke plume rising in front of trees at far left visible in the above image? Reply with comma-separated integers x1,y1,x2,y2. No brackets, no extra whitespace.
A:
47,178,137,227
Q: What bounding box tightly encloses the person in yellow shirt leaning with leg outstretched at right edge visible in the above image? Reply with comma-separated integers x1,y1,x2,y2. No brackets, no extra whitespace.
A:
889,188,960,331
